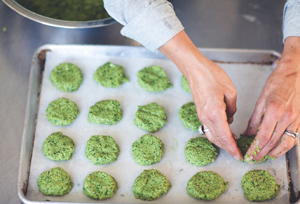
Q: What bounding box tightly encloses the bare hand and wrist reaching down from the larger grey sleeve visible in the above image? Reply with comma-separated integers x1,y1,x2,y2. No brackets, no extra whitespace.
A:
159,31,243,160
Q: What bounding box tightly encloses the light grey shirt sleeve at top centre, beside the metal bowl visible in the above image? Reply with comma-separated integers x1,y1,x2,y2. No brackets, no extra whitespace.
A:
104,0,184,51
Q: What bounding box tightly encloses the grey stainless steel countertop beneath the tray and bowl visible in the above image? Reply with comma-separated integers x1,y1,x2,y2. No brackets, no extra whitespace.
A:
0,0,285,204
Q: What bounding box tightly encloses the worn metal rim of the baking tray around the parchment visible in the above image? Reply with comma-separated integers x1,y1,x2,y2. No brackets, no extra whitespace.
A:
18,45,300,203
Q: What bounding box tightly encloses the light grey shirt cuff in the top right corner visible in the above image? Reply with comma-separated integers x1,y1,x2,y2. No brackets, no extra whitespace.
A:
282,0,300,42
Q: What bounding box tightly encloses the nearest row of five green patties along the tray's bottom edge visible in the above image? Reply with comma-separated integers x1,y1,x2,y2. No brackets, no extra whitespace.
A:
37,167,280,201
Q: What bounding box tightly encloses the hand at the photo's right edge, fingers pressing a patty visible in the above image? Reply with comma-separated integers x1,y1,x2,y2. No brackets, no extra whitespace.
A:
245,37,300,162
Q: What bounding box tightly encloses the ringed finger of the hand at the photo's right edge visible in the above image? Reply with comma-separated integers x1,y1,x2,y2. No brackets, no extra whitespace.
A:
268,125,299,158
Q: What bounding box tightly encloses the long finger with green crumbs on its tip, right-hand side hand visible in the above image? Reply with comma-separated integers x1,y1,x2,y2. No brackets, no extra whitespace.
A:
245,108,278,162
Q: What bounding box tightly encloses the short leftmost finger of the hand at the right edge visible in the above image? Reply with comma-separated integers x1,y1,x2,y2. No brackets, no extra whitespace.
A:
244,105,264,136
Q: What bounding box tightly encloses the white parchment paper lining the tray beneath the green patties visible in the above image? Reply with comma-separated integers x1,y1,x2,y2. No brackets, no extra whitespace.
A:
26,49,289,203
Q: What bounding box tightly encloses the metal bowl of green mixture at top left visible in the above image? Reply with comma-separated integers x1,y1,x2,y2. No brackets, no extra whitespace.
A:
3,0,116,28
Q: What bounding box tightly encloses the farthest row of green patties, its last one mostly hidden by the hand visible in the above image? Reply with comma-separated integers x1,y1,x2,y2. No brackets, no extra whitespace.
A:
50,62,191,93
